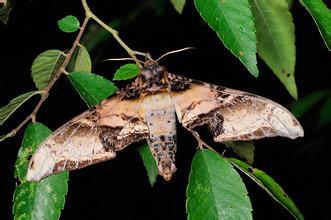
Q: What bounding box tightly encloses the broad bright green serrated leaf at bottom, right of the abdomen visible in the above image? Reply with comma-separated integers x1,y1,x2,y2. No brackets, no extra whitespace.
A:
186,150,252,220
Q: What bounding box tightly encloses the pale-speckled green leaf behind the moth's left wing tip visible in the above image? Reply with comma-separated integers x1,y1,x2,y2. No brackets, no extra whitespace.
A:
13,123,68,220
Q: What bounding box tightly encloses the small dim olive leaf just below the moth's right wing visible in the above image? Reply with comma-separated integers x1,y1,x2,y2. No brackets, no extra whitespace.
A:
224,141,255,164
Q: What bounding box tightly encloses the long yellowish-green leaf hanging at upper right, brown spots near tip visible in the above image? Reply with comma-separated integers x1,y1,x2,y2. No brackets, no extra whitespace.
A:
250,0,298,99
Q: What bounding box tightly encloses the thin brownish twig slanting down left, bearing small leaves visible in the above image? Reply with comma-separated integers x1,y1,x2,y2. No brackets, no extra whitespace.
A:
5,16,90,136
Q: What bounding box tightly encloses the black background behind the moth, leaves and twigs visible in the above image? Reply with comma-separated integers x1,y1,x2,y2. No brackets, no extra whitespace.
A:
0,0,331,219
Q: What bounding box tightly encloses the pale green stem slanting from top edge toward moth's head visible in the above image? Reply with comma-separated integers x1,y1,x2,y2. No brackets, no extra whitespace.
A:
82,0,142,68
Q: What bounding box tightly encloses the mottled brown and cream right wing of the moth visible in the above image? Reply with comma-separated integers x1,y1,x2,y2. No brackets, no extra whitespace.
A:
169,74,303,142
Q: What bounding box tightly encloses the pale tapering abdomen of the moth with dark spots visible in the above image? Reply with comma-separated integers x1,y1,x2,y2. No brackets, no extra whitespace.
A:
142,92,176,180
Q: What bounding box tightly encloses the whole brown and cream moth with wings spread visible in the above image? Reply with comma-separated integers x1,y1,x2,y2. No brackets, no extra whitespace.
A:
27,59,304,181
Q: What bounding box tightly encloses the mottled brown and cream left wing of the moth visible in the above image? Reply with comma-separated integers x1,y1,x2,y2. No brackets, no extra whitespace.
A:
27,92,149,181
